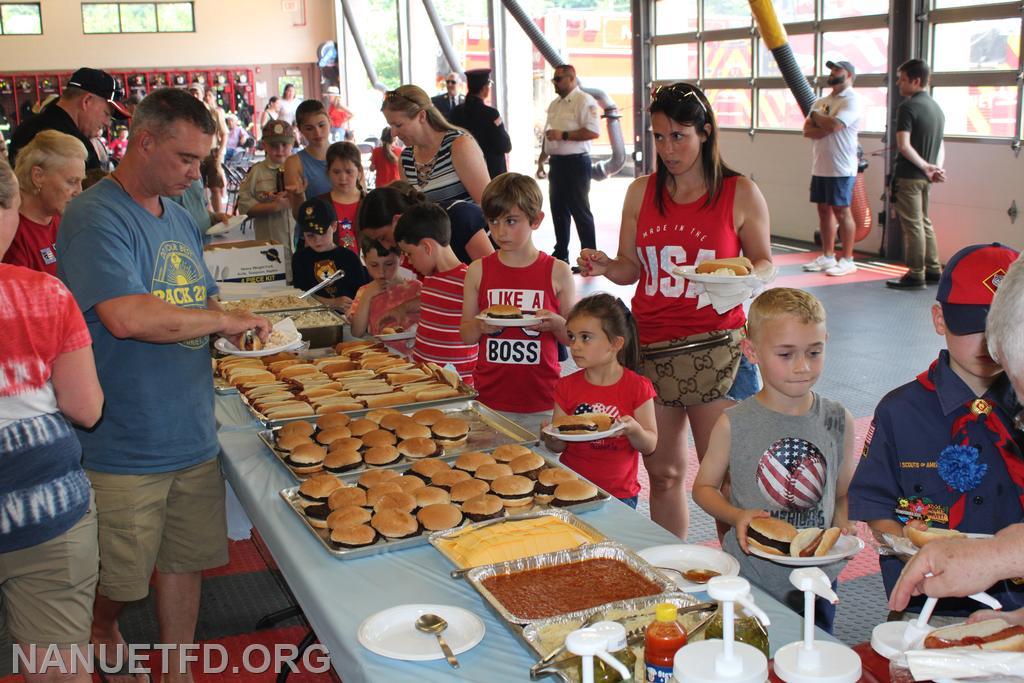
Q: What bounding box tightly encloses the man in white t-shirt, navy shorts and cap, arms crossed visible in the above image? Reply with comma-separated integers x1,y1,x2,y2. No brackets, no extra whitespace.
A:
804,61,863,276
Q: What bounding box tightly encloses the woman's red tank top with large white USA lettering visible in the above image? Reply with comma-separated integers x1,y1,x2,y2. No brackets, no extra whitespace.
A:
633,175,746,344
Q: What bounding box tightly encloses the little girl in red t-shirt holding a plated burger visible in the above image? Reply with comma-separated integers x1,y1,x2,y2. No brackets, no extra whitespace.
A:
541,293,657,508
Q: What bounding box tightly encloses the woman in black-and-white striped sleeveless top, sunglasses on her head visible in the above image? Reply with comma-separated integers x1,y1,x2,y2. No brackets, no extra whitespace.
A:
381,85,490,210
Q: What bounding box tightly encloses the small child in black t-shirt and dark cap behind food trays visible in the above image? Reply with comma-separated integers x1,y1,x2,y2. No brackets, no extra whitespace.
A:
292,199,370,312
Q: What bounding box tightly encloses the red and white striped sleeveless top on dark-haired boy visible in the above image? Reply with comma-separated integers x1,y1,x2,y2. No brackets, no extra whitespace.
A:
413,263,478,385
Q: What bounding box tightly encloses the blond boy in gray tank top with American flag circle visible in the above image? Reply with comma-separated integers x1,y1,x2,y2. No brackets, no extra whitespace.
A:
693,288,856,633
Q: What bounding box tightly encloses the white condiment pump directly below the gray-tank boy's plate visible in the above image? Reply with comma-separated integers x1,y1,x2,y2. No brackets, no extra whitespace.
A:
775,567,861,683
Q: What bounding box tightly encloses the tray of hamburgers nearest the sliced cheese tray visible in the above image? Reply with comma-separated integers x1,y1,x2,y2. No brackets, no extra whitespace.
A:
281,445,608,559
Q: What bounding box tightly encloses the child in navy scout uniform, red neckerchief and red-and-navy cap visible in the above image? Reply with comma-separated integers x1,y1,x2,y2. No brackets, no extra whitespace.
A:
850,244,1024,615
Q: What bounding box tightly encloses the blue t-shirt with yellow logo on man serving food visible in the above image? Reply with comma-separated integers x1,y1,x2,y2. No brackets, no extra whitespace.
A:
57,179,219,474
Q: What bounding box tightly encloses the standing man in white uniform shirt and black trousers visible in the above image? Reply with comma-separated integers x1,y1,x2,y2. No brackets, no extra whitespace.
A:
537,65,601,270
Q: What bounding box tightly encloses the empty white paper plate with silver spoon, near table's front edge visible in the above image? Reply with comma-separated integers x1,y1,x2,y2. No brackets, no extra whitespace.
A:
357,604,485,661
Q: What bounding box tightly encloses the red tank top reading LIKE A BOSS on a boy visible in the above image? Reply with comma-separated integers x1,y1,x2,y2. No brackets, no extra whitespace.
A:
473,252,559,413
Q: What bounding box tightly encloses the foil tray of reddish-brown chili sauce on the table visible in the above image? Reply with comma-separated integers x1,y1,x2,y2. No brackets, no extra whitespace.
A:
466,542,676,626
